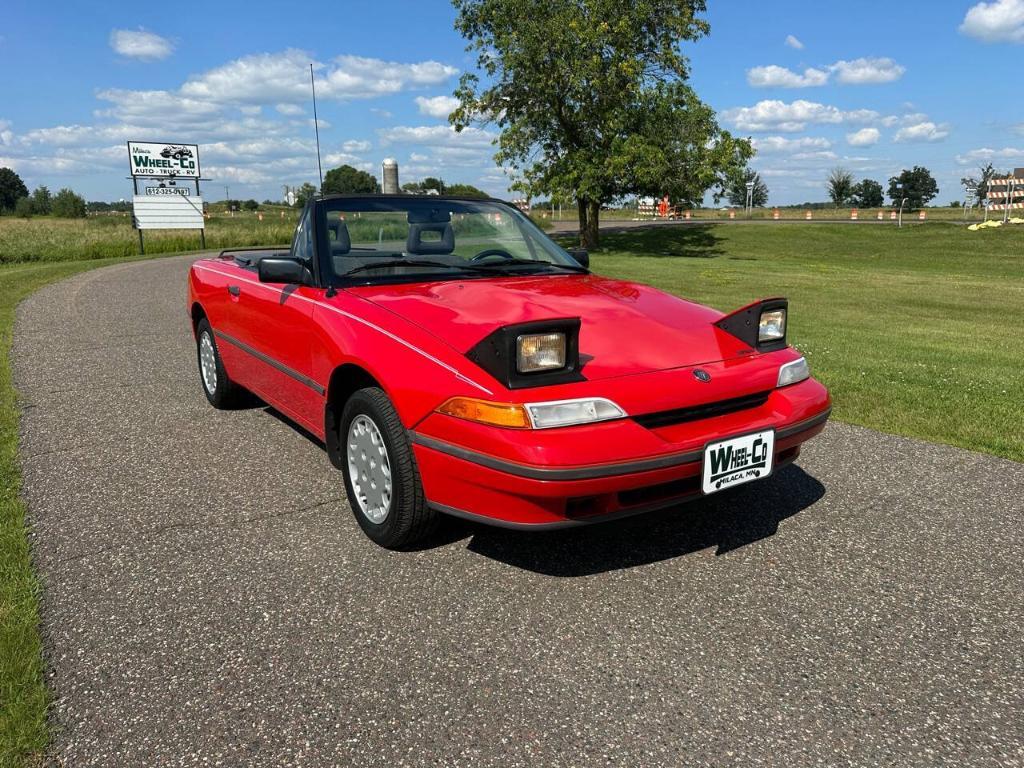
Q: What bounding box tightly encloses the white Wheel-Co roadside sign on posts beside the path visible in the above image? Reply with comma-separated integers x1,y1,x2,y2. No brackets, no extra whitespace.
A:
128,141,206,254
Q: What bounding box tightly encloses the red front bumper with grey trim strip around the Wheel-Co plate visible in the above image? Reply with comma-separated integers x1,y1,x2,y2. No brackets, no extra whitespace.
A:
411,380,831,530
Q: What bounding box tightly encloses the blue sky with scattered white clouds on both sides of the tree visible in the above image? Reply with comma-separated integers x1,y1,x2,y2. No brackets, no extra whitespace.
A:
0,0,1024,205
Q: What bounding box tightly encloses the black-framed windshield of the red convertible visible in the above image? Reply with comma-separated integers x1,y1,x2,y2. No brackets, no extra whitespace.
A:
318,195,586,285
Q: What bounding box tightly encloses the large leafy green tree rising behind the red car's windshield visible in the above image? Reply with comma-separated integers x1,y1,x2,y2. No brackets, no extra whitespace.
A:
451,0,752,248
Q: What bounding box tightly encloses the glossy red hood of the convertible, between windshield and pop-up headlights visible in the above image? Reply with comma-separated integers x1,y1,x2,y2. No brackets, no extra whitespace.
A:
348,274,752,381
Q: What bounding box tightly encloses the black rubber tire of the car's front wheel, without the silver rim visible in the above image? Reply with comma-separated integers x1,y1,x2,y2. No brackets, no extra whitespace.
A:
338,387,439,549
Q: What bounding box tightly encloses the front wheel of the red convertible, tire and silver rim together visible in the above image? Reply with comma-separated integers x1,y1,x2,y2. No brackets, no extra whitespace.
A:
338,387,437,549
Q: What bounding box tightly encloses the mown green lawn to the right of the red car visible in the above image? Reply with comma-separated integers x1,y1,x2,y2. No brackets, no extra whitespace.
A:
577,224,1024,461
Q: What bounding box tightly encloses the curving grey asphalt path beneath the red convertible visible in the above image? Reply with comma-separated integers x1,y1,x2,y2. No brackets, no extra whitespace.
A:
15,258,1024,768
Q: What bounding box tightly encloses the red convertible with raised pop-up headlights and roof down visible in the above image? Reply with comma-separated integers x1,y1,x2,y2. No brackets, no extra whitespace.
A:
188,195,830,547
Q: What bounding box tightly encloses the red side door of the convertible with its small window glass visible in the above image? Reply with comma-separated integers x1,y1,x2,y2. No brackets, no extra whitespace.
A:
240,205,324,431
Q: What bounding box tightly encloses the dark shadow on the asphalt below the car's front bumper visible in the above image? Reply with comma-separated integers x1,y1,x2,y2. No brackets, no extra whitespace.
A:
468,465,825,577
